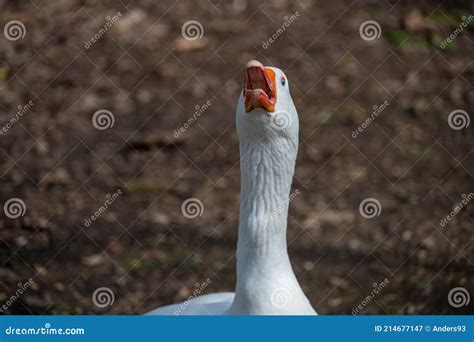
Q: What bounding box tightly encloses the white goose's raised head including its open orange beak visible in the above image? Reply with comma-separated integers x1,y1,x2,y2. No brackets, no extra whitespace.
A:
236,60,299,154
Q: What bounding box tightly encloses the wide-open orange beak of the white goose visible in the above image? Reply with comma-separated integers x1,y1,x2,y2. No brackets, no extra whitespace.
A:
244,60,277,113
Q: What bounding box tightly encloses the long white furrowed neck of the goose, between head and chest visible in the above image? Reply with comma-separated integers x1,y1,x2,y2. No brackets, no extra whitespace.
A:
237,140,296,281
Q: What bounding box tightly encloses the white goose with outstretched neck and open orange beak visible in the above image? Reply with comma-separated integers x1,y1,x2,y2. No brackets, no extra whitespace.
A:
149,60,316,315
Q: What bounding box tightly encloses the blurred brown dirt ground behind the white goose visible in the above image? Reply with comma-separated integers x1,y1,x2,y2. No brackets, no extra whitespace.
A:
0,0,474,314
